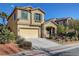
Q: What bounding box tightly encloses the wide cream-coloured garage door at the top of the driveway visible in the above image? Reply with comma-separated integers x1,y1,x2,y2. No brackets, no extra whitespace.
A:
19,29,38,38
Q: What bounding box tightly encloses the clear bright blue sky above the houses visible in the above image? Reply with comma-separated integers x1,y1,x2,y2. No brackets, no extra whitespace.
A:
0,3,79,20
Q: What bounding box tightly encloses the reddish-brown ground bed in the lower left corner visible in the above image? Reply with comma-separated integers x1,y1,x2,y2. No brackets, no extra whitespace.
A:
0,43,23,55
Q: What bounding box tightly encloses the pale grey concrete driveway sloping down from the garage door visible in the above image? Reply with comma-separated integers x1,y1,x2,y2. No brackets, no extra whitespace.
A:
25,38,61,48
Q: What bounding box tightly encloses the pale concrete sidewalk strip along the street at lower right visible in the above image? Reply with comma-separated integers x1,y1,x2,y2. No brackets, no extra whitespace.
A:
45,43,79,55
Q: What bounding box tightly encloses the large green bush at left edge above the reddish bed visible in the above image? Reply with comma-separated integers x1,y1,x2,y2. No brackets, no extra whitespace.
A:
0,27,15,43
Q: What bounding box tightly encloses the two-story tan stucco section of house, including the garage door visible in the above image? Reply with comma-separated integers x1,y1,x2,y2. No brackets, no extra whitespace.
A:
8,7,45,38
